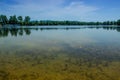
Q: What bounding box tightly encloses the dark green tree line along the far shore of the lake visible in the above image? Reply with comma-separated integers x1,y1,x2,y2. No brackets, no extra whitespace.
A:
0,15,120,26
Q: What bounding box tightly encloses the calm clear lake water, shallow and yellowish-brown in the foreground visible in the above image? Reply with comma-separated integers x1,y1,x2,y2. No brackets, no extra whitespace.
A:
0,26,120,80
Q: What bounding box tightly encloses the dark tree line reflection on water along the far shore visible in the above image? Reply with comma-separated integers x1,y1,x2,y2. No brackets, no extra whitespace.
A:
0,26,120,37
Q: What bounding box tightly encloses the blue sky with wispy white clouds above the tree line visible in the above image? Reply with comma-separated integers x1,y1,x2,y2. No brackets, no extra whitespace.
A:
0,0,120,21
